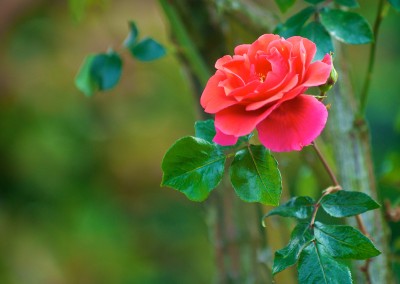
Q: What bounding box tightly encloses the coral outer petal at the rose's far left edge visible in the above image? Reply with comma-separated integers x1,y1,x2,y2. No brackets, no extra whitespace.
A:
200,71,237,113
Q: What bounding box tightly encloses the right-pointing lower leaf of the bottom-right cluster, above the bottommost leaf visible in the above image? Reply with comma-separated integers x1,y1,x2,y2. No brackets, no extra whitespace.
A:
314,222,380,259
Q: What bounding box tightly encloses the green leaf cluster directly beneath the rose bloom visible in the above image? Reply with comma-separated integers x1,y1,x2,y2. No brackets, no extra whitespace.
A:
161,120,282,205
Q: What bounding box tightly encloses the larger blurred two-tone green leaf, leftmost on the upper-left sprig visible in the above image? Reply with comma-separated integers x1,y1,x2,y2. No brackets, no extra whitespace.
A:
75,50,122,96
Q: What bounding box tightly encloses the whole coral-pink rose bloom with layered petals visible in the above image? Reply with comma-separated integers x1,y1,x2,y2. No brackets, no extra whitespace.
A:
200,34,332,152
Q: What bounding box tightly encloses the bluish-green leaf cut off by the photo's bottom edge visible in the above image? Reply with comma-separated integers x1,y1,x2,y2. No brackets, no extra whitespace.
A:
297,241,353,284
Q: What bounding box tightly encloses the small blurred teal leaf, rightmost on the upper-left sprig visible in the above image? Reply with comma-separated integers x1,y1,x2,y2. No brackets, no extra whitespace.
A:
129,38,166,61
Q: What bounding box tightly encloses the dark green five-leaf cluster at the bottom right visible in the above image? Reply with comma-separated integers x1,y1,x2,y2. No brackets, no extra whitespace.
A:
265,190,380,284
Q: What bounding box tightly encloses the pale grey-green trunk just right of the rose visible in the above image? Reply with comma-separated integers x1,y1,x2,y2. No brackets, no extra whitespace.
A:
327,46,393,284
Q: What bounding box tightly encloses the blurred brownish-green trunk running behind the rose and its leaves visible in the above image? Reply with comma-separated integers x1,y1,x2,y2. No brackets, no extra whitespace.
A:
160,0,280,284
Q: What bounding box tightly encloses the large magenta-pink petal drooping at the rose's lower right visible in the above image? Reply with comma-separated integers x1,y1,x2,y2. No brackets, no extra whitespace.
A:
257,95,328,152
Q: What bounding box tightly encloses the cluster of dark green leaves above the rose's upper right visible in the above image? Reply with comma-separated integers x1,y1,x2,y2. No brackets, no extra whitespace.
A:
274,0,374,60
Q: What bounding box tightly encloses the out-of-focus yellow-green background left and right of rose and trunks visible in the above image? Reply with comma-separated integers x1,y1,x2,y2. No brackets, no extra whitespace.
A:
0,0,400,284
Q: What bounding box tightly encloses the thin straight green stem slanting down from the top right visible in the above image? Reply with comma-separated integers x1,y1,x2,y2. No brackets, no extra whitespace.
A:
357,0,388,119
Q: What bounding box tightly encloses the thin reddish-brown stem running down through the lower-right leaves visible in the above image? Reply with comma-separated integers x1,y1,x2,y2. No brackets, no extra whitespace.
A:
310,141,371,284
